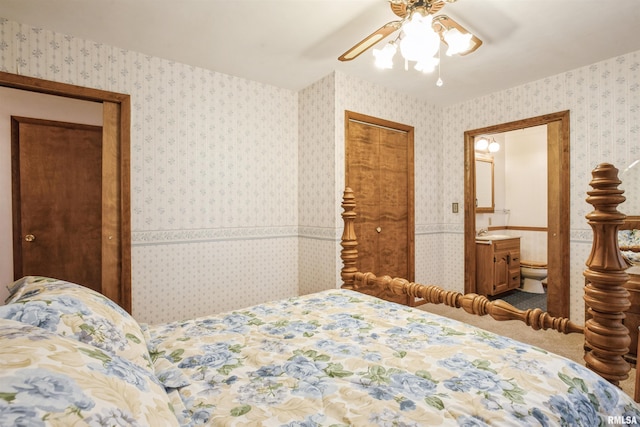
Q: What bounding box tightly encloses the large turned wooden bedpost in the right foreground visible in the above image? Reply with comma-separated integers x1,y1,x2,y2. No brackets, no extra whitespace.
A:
584,163,631,385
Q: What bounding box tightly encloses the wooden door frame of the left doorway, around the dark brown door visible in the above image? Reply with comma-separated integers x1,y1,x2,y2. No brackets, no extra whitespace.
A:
0,72,132,313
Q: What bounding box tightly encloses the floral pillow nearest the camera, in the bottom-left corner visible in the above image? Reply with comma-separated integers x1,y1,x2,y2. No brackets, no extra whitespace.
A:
0,319,179,426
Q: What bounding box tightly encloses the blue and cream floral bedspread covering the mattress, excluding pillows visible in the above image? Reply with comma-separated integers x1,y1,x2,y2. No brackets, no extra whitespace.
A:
146,290,640,427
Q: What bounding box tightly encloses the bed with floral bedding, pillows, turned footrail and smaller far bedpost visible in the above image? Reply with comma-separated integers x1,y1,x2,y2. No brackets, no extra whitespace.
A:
0,163,640,426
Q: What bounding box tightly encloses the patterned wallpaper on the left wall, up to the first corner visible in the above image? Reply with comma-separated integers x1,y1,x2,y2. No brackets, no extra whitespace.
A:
0,18,298,322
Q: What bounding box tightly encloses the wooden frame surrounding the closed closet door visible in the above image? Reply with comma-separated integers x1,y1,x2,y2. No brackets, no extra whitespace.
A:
344,110,415,282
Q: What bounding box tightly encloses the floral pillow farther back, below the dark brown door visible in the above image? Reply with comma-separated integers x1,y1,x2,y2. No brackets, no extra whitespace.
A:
0,276,153,371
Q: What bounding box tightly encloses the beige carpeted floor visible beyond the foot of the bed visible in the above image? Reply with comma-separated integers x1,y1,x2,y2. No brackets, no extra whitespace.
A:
419,304,636,397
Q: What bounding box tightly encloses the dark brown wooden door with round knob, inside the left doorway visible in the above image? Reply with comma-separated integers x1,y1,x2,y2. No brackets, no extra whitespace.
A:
11,117,102,292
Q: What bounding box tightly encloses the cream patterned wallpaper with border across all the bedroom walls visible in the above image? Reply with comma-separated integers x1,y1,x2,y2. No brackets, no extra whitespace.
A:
0,12,640,322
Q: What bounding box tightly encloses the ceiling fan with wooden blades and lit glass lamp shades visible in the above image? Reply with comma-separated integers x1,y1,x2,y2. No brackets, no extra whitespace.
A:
338,0,482,71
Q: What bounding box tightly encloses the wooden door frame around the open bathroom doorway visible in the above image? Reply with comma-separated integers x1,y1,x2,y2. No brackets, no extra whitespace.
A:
464,110,571,317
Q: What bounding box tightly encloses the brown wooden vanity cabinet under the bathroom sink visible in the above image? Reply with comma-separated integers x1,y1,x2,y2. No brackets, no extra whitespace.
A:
476,237,520,296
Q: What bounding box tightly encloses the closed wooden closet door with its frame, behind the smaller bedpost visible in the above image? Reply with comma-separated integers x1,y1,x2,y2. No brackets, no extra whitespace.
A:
345,112,414,305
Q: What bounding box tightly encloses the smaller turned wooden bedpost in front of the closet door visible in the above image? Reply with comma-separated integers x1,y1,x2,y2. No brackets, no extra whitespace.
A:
340,187,358,289
